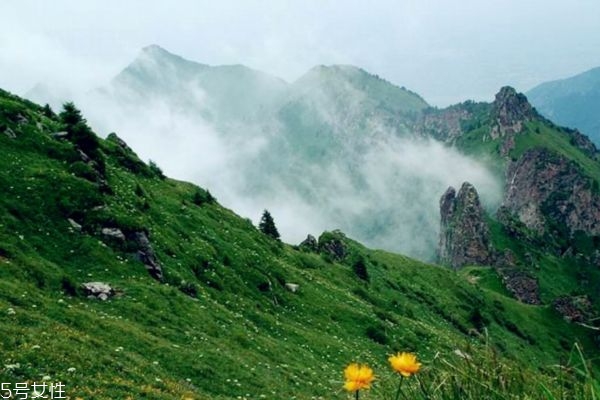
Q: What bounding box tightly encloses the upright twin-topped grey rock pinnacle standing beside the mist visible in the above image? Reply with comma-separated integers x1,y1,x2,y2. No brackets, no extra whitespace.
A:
438,182,493,268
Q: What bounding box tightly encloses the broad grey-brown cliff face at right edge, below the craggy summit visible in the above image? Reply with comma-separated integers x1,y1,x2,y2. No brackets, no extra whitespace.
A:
503,148,600,235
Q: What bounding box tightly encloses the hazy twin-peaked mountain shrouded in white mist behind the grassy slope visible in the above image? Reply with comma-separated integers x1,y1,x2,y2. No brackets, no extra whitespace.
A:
74,46,501,261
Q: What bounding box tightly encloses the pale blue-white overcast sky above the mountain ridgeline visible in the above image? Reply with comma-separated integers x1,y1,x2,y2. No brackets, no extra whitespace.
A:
0,0,600,107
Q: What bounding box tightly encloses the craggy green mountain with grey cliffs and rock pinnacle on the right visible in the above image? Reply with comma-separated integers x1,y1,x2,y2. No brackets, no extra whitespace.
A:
421,87,600,318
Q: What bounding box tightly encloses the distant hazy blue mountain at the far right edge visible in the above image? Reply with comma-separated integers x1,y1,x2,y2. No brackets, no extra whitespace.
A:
527,67,600,145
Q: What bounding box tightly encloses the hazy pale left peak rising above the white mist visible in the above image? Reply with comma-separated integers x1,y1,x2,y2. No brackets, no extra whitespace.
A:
102,45,287,123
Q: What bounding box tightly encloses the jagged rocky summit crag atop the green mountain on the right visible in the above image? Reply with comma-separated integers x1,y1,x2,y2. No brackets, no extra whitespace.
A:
490,86,537,139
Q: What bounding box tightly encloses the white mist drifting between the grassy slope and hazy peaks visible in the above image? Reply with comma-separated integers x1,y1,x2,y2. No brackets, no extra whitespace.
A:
61,73,502,261
